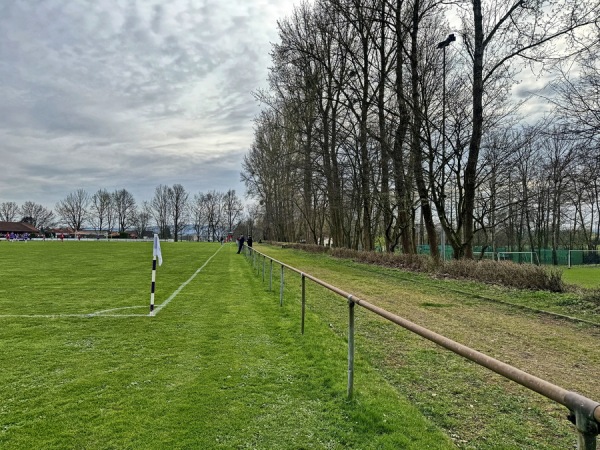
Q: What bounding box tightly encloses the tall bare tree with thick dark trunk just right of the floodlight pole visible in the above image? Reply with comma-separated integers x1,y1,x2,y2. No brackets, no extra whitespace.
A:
461,0,600,258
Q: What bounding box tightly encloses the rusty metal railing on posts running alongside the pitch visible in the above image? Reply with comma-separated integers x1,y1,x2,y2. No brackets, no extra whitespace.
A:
244,247,600,450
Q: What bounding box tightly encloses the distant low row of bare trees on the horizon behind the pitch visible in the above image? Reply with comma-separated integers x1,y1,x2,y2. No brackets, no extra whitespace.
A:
0,184,244,241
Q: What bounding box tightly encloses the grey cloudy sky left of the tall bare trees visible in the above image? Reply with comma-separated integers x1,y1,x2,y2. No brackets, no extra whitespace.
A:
0,0,294,209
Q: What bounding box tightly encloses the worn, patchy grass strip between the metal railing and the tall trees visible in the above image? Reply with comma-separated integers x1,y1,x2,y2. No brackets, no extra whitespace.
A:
250,246,600,450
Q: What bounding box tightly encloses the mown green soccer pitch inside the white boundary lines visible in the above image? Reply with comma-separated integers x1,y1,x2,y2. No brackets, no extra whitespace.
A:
0,241,220,317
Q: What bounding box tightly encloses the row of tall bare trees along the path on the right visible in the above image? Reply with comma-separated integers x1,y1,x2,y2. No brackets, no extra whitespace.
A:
242,0,600,258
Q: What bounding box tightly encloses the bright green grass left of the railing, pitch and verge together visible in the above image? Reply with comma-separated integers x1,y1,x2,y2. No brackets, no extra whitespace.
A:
0,242,453,449
